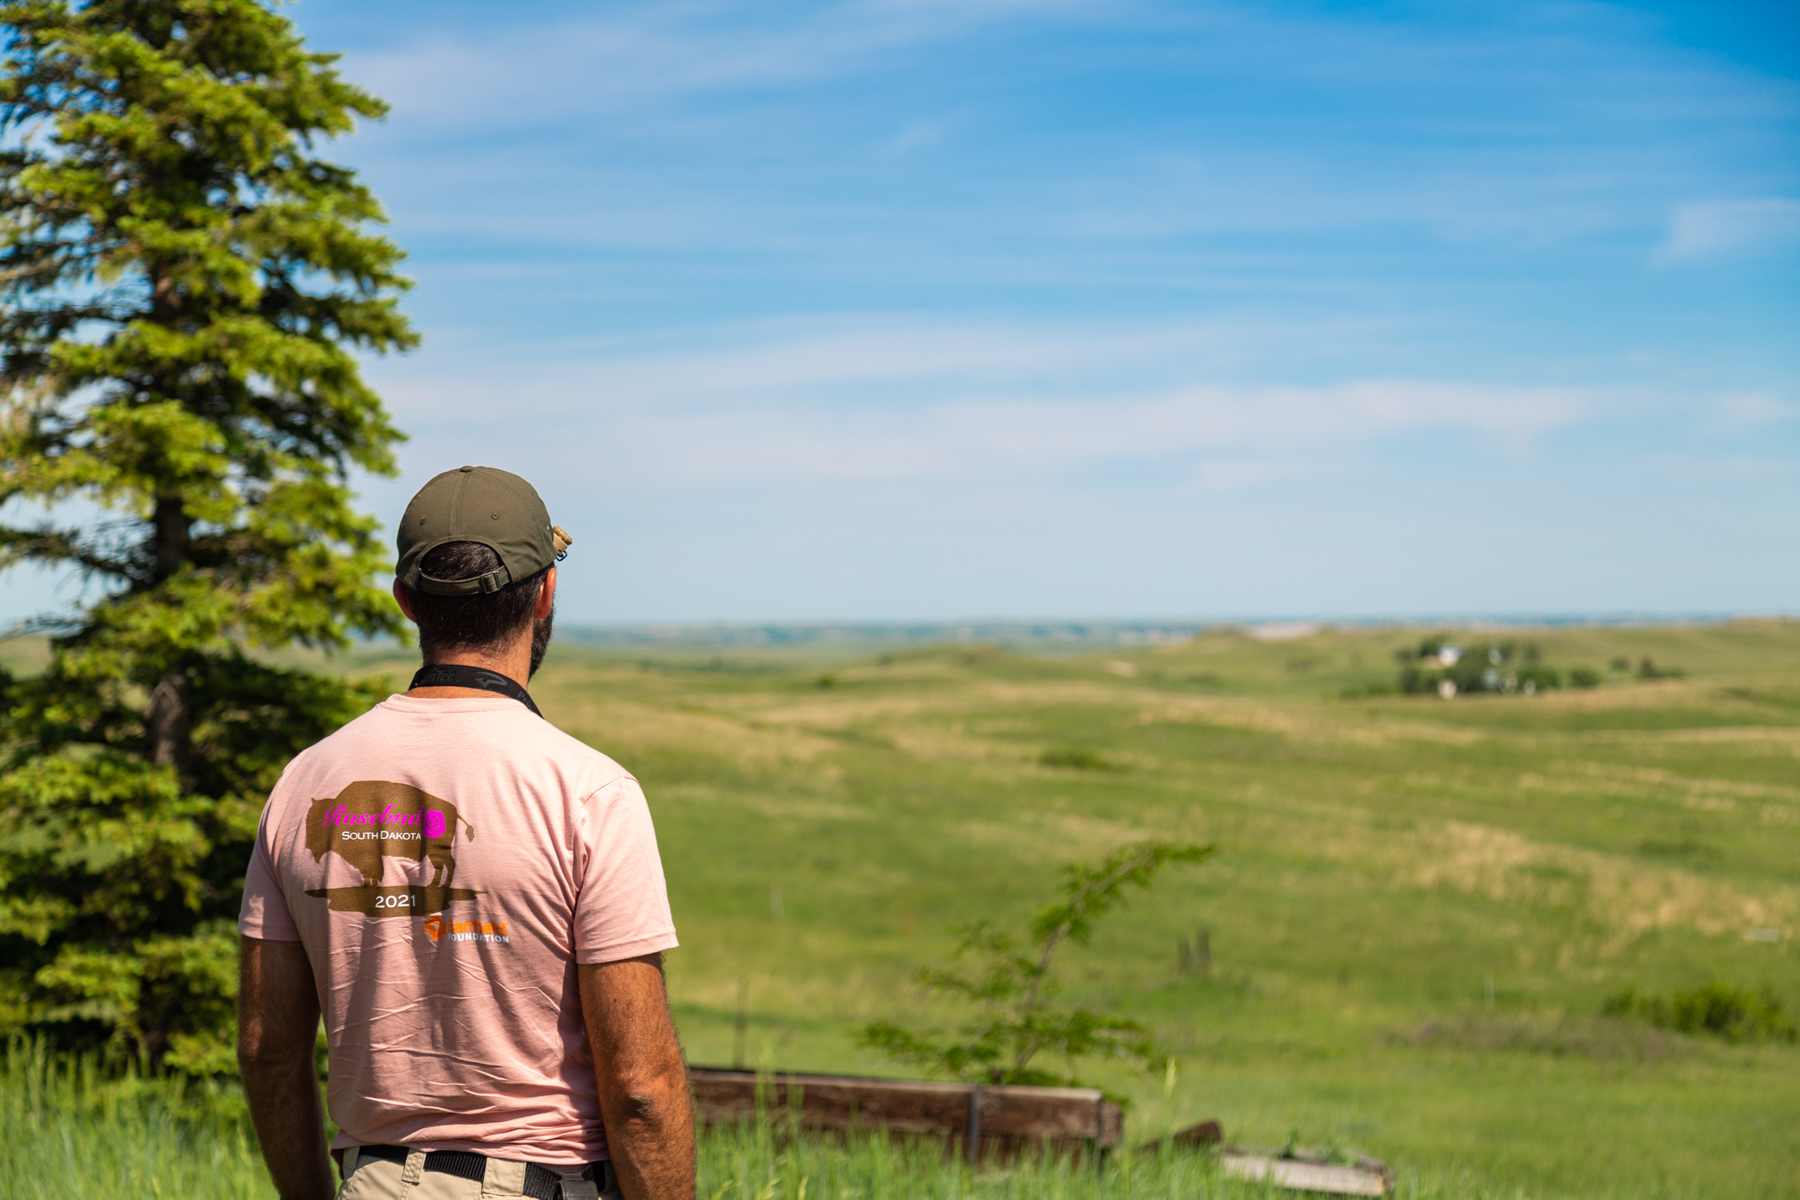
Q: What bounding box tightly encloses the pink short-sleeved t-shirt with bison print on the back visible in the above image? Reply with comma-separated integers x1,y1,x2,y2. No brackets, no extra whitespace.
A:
238,696,675,1166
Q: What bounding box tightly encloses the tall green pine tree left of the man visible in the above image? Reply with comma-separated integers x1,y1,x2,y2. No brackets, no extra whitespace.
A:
0,0,416,1072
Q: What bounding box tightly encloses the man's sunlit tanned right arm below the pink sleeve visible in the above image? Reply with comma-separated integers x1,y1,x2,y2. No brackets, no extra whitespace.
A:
578,954,693,1200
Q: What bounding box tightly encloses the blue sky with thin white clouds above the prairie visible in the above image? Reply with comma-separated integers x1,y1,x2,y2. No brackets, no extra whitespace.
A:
5,0,1800,621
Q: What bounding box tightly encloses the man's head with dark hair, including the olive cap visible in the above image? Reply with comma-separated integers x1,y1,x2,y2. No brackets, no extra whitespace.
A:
394,466,574,673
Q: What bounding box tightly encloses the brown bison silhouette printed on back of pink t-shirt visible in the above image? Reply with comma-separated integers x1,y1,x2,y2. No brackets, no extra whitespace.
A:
306,779,475,887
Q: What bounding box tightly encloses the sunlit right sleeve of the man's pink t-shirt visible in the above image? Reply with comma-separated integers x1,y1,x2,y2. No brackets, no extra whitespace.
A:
574,775,677,963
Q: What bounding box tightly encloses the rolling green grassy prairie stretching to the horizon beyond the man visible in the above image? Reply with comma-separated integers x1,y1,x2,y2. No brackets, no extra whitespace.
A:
9,622,1800,1196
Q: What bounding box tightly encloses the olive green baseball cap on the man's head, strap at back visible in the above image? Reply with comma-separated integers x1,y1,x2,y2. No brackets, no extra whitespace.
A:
394,466,574,596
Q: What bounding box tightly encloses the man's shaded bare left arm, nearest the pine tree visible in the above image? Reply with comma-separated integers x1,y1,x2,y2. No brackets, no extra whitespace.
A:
238,937,333,1200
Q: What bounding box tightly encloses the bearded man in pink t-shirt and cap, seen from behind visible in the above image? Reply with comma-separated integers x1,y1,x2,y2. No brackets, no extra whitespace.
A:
238,466,695,1200
